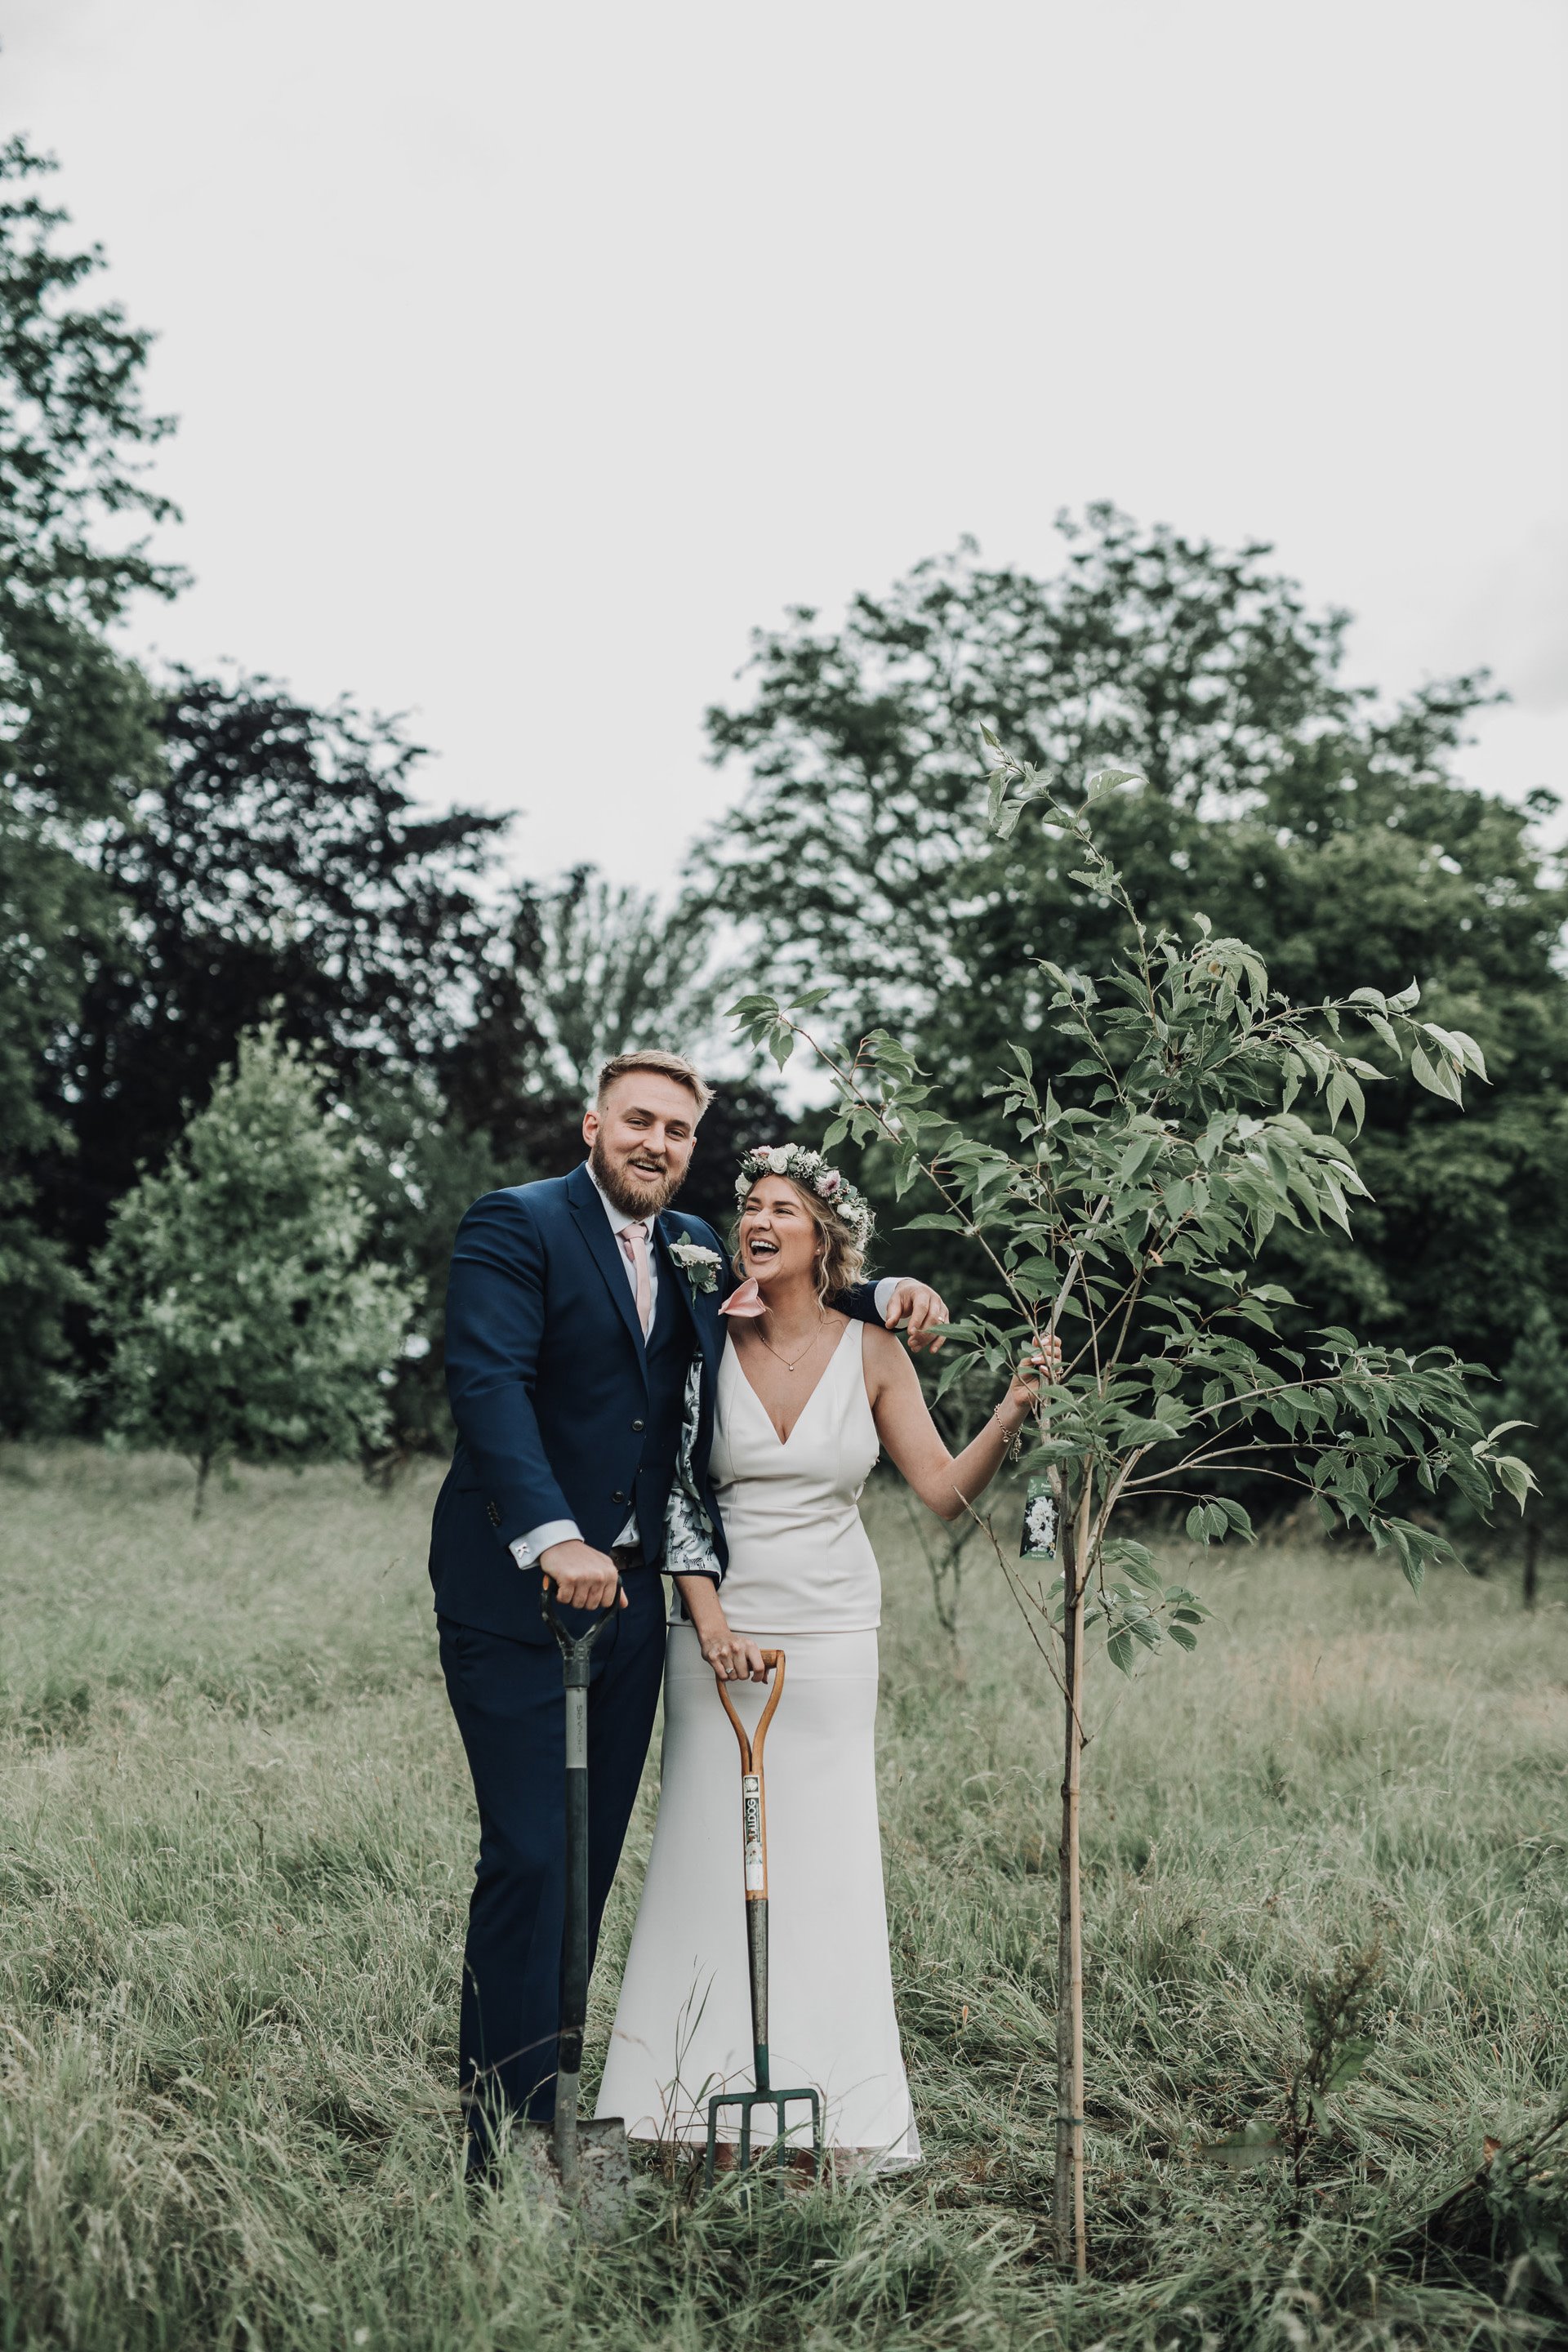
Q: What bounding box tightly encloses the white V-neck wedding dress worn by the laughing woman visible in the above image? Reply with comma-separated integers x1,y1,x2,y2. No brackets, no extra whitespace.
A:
597,1322,920,2171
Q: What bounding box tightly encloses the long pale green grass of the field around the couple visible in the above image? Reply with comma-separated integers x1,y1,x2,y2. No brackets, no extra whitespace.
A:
0,1449,1568,2352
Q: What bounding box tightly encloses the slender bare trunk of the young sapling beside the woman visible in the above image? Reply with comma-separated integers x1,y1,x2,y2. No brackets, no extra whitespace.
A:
1054,1480,1094,2279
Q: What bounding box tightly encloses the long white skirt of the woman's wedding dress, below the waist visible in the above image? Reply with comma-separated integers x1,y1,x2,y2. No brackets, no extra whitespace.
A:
597,1625,920,2171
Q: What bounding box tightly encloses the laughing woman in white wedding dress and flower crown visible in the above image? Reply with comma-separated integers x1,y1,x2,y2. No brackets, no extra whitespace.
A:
599,1146,1060,2171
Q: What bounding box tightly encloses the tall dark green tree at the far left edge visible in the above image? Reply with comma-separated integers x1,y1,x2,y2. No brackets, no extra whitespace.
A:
0,139,176,1428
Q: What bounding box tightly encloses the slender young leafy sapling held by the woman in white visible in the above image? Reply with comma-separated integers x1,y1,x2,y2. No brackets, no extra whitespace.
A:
736,738,1530,2277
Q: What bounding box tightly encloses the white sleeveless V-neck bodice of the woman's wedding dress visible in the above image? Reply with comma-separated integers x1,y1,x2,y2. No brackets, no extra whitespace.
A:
712,1322,881,1635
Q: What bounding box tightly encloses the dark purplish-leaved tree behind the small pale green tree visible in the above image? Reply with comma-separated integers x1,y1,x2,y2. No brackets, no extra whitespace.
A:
45,673,506,1258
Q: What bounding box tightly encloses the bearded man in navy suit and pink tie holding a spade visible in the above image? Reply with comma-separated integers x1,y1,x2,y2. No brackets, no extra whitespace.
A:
430,1054,947,2171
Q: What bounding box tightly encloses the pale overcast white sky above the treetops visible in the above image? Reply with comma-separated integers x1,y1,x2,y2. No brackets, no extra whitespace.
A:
0,0,1568,882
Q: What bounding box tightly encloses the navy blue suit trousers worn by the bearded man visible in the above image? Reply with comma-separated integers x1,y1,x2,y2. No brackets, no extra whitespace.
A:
437,1569,666,2157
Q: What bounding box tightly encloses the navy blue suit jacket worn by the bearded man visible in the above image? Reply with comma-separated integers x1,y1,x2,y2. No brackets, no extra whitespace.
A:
430,1165,877,1642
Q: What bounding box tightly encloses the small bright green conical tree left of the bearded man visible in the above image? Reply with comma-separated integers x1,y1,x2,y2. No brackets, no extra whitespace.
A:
94,1030,414,1510
